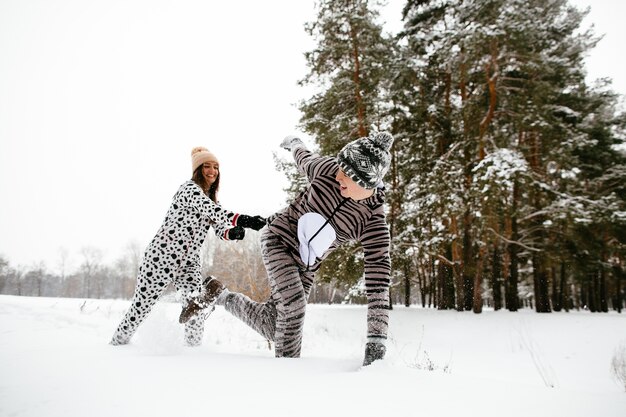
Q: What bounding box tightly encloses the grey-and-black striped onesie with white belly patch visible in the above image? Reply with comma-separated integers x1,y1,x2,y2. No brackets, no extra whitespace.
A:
219,147,391,357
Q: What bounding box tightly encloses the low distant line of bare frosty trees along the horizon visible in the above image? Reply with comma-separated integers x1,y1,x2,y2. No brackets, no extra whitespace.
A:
0,230,348,303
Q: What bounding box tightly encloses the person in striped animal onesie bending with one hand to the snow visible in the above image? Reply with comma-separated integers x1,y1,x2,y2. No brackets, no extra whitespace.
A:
179,133,393,365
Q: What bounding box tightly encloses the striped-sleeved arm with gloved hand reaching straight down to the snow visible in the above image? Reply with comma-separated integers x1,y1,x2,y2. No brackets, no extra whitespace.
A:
361,213,391,365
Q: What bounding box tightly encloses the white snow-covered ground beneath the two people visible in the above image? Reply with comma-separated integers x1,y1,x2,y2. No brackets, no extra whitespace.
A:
0,296,626,417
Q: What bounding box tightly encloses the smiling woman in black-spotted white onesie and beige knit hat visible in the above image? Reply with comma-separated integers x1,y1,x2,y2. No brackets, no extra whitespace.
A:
111,147,265,346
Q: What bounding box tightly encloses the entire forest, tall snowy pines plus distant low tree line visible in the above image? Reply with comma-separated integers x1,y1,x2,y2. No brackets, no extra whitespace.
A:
0,0,626,313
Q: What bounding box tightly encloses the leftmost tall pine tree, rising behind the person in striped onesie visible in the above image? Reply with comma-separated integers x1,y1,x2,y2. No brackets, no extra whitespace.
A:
300,0,394,292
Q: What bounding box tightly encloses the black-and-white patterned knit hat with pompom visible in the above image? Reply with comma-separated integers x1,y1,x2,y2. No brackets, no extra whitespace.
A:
337,132,393,190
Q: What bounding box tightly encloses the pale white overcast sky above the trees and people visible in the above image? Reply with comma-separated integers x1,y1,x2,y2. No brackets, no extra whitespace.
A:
0,0,626,270
